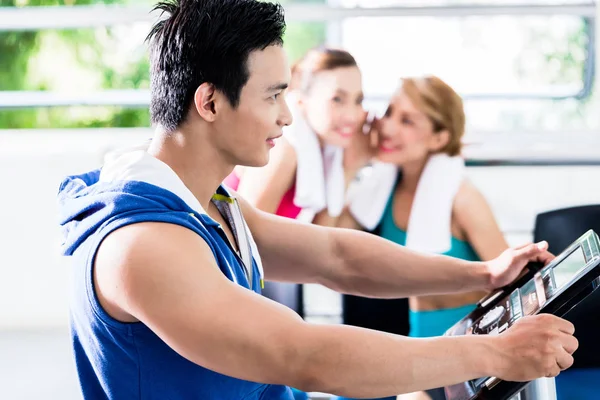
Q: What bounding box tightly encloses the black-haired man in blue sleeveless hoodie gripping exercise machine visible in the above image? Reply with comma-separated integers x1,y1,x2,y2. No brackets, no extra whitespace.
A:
59,0,577,400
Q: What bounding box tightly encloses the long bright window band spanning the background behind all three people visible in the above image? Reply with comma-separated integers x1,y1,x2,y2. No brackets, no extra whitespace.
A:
0,0,600,130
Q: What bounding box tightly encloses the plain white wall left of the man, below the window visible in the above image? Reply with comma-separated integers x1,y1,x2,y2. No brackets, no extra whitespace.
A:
0,131,148,329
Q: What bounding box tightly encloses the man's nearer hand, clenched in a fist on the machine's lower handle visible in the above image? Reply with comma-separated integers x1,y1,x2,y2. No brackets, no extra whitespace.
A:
491,314,579,382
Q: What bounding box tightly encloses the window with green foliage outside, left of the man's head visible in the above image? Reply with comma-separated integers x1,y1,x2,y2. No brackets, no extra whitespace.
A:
0,23,150,129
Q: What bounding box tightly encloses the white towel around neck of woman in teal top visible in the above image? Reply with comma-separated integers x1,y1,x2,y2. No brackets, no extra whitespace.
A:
350,154,465,253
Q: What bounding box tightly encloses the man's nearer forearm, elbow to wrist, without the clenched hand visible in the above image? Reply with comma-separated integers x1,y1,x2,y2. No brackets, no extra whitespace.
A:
299,326,496,398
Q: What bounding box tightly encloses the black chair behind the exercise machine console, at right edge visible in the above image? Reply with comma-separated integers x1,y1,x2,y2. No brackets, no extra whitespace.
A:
533,205,600,368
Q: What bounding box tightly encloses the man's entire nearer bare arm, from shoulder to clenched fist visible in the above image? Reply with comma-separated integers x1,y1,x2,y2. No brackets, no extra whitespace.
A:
95,223,574,397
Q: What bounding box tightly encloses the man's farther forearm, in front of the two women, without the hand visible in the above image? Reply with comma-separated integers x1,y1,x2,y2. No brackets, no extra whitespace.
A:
322,229,490,298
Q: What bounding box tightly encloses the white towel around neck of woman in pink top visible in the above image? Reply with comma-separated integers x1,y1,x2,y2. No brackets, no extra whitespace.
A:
283,93,345,222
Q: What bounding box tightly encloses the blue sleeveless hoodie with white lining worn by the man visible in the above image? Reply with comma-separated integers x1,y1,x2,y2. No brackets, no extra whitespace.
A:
58,150,293,400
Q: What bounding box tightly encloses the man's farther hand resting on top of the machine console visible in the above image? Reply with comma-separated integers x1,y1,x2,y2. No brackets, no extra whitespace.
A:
486,241,554,290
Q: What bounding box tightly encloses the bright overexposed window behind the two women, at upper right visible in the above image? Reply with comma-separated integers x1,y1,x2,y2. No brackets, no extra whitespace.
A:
340,0,600,132
